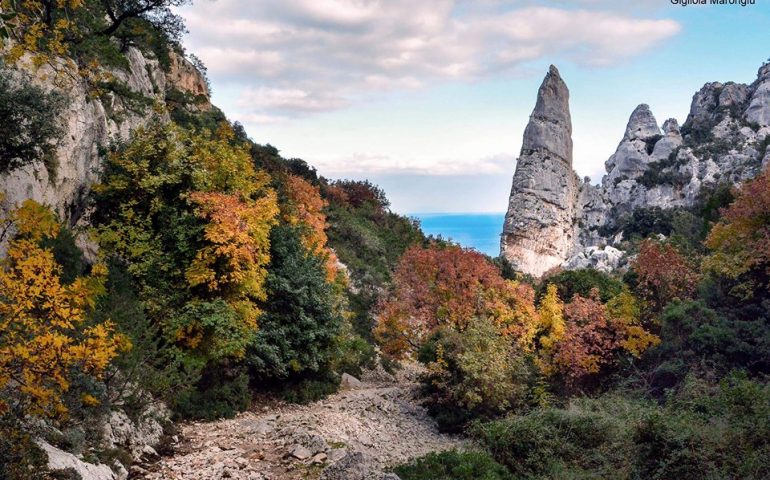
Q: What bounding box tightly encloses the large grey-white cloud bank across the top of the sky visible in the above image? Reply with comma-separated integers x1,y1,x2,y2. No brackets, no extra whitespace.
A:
182,0,680,118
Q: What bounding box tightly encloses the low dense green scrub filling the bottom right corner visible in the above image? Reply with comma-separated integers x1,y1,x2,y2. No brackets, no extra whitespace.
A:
474,375,770,480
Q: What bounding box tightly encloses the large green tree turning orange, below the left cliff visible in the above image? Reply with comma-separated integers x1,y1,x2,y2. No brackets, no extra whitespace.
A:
93,122,278,364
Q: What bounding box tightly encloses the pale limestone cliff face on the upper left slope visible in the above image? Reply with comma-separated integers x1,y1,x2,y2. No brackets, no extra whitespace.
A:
0,48,210,229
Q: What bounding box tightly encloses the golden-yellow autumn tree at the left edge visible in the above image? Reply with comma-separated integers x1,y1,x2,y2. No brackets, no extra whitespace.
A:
0,200,130,417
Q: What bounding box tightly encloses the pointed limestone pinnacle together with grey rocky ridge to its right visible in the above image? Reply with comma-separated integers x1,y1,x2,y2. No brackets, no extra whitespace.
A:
501,64,770,277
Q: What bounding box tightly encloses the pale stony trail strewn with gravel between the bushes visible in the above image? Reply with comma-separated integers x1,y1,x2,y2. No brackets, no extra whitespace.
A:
132,369,465,480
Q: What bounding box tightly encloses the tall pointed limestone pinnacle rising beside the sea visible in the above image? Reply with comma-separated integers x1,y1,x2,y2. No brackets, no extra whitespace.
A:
501,66,580,276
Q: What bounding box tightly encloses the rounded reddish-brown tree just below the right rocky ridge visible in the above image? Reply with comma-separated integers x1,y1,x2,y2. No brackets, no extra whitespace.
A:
631,239,699,314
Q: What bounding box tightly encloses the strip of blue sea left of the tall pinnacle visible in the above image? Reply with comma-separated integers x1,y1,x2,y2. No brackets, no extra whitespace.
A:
409,213,505,257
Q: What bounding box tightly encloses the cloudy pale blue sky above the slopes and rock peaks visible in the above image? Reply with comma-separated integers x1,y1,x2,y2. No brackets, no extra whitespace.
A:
180,0,770,213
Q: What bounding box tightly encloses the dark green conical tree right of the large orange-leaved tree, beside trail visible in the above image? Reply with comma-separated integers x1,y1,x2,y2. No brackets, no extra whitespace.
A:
247,225,343,379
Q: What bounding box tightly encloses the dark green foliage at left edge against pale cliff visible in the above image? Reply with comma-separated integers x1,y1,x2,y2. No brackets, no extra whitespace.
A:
0,63,65,176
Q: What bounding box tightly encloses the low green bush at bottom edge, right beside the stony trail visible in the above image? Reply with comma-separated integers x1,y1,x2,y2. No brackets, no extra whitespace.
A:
395,450,514,480
